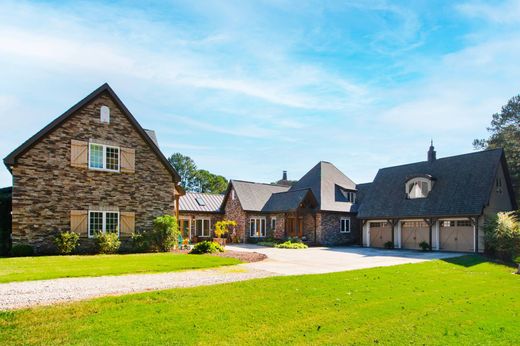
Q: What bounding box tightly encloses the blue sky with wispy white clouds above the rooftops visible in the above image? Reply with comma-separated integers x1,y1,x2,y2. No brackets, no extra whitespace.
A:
0,0,520,186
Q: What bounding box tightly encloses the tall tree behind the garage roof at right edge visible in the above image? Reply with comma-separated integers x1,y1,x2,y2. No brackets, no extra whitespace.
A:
473,95,520,203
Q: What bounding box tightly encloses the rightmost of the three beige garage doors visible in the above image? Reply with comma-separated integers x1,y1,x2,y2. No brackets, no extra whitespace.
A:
439,220,474,252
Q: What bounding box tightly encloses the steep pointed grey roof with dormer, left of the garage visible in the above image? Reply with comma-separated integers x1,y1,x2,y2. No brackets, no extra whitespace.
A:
291,161,356,212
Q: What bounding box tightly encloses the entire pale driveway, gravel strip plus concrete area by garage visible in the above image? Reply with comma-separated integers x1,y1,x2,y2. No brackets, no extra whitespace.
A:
0,245,461,310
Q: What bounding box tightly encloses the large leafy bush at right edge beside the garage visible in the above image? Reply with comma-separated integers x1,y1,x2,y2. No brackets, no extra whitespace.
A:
484,212,520,262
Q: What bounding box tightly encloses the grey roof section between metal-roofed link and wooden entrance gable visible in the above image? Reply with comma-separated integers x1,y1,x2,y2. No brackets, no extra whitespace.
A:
230,180,289,211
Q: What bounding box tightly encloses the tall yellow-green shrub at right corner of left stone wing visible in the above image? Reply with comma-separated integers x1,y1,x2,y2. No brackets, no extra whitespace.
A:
147,215,180,252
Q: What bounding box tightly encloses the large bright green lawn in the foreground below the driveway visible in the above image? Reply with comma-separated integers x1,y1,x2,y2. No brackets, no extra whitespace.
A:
0,256,520,345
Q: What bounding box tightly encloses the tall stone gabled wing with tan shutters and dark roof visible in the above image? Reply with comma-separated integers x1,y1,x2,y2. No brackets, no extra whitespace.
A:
4,84,182,253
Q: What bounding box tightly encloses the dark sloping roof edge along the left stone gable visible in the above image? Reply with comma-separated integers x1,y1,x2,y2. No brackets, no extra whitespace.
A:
4,83,181,182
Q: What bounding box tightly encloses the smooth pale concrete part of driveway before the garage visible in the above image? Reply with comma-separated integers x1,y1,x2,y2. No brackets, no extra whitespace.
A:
226,244,464,275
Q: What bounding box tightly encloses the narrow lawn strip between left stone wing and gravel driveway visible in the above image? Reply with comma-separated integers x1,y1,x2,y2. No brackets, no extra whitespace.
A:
0,253,240,283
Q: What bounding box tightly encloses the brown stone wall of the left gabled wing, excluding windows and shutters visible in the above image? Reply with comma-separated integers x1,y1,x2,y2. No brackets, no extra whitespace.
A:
12,92,175,253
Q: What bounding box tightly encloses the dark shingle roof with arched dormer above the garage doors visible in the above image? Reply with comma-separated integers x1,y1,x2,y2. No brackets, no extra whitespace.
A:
358,149,516,219
